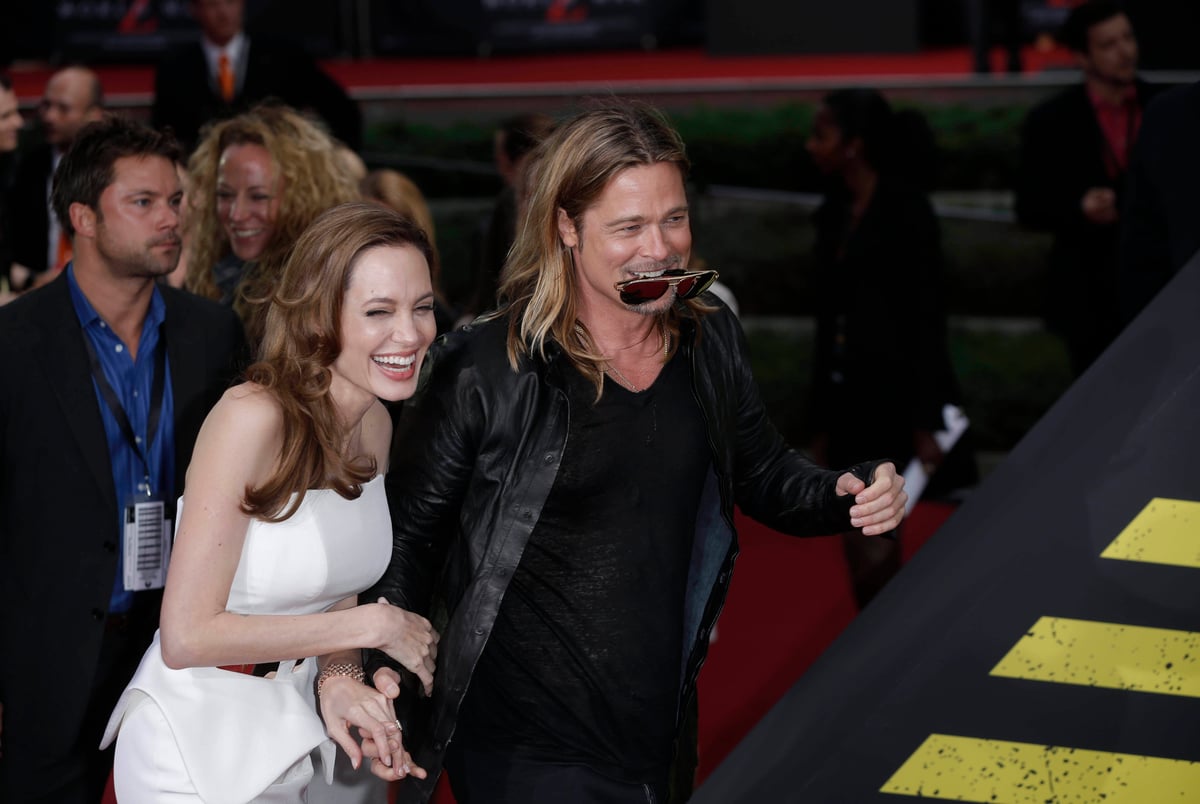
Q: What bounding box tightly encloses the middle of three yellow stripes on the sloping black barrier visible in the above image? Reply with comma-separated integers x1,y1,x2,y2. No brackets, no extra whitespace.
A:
991,617,1200,697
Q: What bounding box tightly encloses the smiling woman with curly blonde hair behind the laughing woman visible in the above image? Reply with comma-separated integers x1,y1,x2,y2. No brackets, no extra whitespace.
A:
187,106,359,346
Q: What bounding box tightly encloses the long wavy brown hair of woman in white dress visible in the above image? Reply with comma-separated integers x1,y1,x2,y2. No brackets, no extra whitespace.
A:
242,202,433,522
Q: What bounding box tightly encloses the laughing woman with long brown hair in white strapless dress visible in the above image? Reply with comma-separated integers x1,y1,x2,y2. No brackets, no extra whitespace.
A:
104,204,437,804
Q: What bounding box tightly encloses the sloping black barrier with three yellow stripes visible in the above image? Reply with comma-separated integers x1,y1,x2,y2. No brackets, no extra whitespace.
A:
692,257,1200,804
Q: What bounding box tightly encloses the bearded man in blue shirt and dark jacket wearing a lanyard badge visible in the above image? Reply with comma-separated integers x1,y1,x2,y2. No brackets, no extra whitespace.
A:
0,118,244,804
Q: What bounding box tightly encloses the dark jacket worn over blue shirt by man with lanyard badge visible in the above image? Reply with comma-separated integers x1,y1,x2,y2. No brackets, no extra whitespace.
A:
0,276,244,802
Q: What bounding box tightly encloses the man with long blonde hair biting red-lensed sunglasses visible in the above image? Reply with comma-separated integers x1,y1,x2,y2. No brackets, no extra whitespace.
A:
367,102,906,804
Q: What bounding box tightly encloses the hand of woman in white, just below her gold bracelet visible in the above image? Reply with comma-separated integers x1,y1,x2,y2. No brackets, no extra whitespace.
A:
318,676,425,781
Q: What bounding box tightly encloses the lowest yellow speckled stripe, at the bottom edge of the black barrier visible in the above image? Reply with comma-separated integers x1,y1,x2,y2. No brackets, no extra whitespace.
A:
880,734,1200,804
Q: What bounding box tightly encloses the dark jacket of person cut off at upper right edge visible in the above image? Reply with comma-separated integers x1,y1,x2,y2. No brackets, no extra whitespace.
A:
1118,83,1200,320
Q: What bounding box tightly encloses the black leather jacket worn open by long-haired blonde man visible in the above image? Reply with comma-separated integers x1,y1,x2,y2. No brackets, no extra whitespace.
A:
362,298,872,802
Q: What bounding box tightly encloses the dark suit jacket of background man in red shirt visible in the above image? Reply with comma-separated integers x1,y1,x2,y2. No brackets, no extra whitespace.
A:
1016,82,1154,367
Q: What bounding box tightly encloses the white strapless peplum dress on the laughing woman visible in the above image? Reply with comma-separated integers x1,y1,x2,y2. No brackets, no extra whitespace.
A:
102,476,391,804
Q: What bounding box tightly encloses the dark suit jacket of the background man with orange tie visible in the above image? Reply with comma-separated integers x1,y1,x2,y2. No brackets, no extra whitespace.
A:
150,34,362,150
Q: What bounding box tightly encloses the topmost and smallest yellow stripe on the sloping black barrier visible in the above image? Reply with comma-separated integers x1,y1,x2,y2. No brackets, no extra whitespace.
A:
1100,497,1200,569
